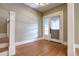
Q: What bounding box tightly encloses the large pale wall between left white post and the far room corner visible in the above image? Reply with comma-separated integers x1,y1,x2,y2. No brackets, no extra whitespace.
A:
0,4,42,42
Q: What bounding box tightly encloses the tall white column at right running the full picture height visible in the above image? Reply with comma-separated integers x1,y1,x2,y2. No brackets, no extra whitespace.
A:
67,3,75,56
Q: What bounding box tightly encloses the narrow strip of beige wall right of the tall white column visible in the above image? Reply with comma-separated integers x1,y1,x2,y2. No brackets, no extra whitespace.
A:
74,3,79,44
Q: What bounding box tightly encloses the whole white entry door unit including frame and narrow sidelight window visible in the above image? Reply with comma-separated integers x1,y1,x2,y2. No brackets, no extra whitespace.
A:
43,11,63,43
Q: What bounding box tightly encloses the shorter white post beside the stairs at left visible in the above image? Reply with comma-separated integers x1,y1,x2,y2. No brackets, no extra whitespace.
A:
9,11,15,55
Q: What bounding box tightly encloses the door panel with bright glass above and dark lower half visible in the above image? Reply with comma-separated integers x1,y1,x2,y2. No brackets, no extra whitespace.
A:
50,15,60,41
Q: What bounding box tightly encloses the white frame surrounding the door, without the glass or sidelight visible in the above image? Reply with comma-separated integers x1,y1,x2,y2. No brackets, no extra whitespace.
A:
43,10,64,43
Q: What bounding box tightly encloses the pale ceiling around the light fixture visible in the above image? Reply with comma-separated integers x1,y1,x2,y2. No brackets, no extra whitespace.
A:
24,3,63,13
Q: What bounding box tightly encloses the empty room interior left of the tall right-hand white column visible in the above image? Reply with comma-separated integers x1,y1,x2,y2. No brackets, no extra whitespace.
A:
0,3,68,56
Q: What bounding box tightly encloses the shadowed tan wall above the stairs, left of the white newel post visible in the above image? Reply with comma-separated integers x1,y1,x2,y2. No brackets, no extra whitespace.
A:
0,8,8,33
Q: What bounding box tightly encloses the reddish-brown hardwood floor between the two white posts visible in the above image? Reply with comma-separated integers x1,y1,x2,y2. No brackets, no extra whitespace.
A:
16,40,67,56
